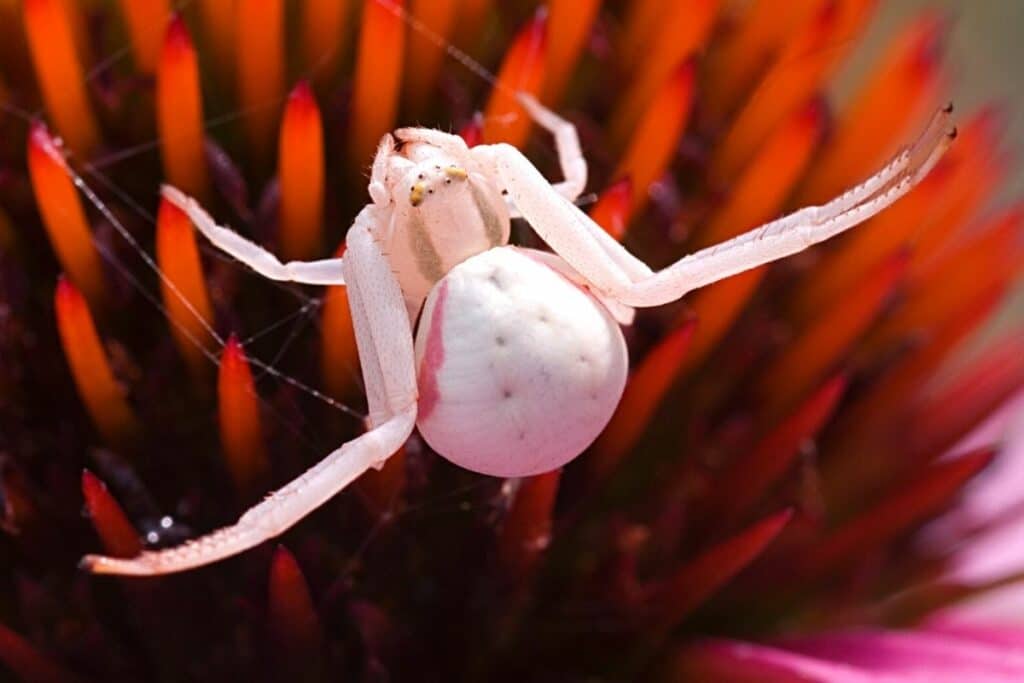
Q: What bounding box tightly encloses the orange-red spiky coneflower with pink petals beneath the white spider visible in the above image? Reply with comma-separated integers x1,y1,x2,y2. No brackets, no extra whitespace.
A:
0,0,1024,682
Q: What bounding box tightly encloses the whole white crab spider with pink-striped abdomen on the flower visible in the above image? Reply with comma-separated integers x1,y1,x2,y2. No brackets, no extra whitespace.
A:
83,96,955,575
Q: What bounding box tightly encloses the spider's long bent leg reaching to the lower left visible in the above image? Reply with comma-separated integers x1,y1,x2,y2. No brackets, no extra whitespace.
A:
81,207,417,575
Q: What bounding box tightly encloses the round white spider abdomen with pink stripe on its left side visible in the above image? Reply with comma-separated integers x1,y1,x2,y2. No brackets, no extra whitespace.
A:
416,247,628,476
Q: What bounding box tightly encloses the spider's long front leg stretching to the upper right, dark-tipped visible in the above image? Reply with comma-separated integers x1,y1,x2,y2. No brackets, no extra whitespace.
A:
473,108,955,306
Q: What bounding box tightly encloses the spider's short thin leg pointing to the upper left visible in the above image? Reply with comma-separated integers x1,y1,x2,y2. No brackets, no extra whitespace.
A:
161,185,345,285
